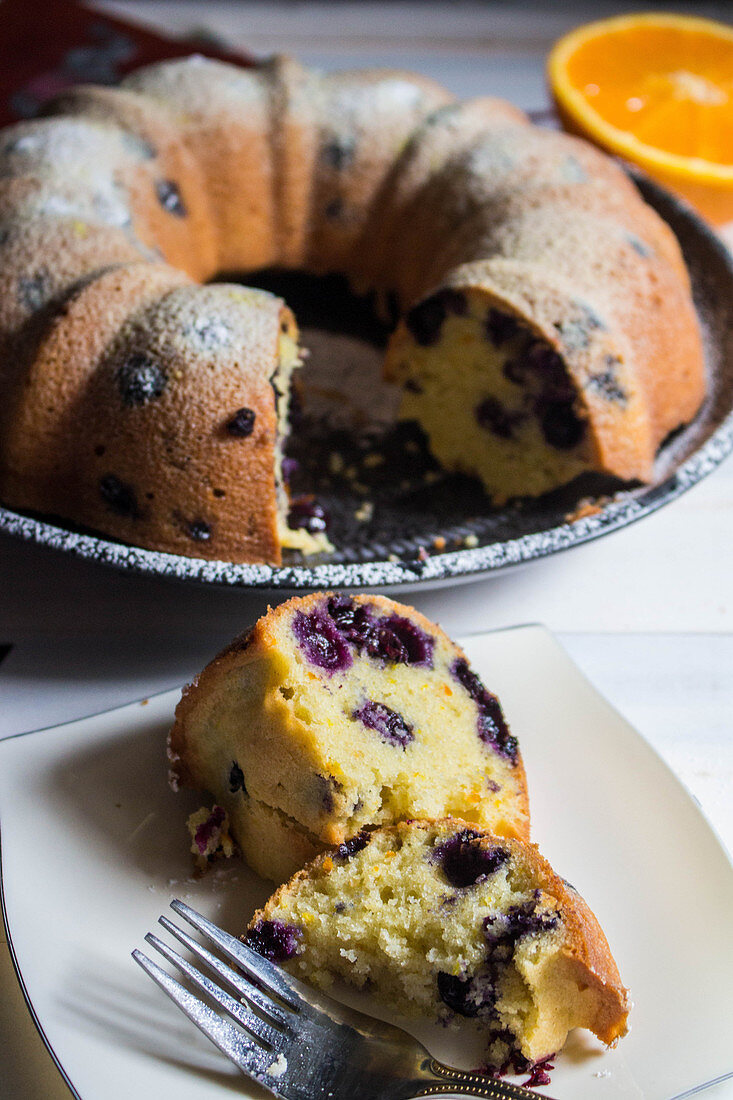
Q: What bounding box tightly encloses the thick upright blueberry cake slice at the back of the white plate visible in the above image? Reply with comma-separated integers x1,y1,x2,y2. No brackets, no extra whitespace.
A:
169,593,529,882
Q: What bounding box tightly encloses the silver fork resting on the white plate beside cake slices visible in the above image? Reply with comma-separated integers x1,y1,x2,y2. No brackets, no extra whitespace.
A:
132,901,550,1100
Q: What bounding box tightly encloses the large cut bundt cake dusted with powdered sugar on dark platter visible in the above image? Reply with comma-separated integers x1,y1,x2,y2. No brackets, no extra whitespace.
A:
0,57,704,563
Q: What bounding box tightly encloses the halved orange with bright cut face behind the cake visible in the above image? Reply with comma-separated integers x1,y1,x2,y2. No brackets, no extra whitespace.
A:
548,13,733,224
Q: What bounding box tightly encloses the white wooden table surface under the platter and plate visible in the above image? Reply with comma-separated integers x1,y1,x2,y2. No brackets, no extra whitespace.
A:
0,0,733,1100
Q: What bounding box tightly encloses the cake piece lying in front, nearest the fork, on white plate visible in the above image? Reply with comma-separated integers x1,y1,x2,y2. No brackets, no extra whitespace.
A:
244,821,628,1070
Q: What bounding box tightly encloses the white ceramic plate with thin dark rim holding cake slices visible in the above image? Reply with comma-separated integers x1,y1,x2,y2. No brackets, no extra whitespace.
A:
0,627,733,1100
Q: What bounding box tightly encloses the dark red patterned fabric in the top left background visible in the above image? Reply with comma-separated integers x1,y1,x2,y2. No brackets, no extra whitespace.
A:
0,0,253,127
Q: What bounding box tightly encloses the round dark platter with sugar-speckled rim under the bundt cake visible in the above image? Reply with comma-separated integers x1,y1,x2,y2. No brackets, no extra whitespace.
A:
0,178,733,591
